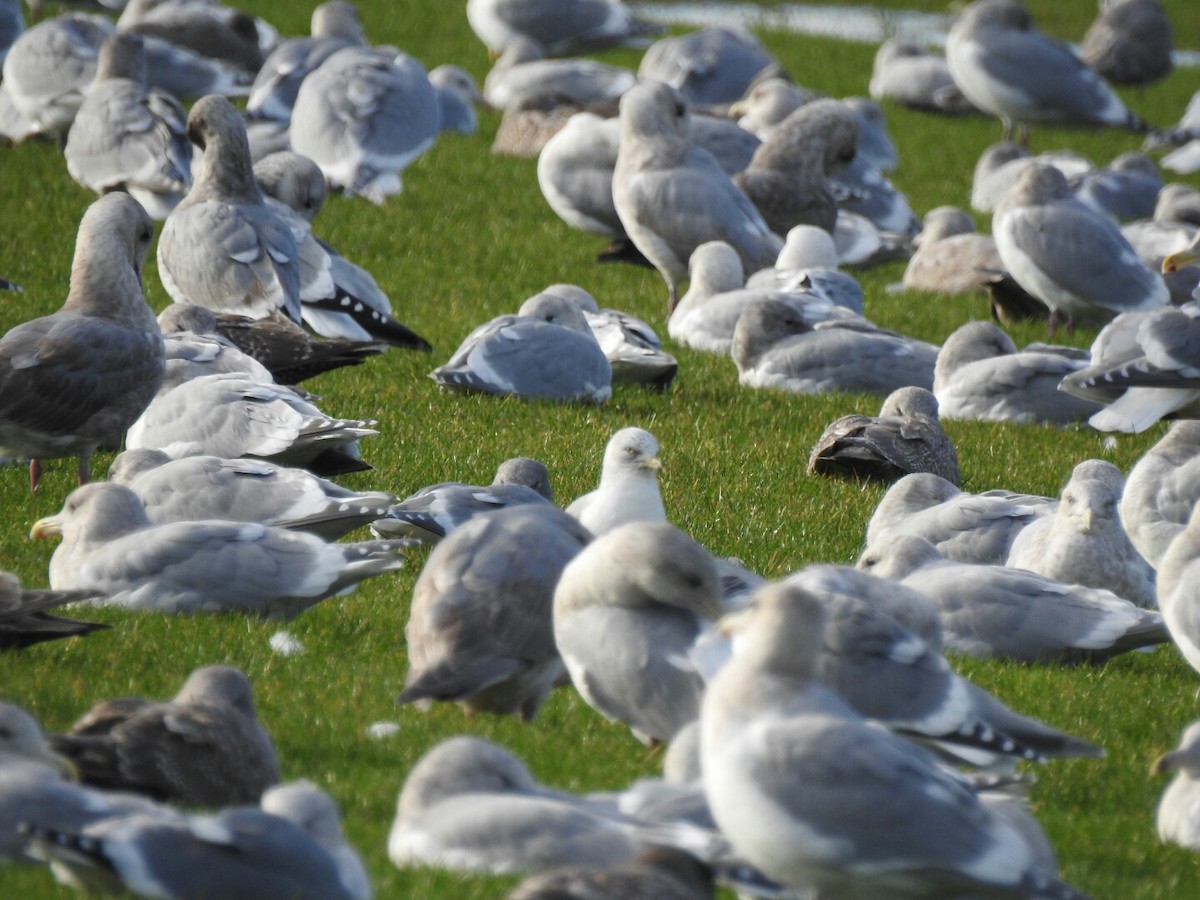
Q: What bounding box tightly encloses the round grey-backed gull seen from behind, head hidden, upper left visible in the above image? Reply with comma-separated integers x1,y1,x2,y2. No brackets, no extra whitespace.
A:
288,47,439,204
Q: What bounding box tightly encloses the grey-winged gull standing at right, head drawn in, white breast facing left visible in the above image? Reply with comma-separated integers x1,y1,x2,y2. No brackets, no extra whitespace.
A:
992,164,1169,332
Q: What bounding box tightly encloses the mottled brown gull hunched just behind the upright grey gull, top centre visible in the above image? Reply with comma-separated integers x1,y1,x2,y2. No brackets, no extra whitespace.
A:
733,100,858,234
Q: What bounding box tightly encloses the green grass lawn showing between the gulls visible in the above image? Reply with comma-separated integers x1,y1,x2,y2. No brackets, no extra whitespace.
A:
0,0,1200,898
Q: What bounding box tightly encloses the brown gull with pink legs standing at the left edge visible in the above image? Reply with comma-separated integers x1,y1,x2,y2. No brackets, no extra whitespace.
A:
0,193,163,490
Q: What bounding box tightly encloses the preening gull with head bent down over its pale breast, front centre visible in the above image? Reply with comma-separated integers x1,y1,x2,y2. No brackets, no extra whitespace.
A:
553,522,722,744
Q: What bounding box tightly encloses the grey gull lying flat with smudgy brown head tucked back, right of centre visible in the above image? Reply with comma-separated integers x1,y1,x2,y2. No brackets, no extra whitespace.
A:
730,299,937,396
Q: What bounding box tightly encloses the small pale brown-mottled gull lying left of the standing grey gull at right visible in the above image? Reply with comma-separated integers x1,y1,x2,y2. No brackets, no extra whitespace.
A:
901,206,1003,294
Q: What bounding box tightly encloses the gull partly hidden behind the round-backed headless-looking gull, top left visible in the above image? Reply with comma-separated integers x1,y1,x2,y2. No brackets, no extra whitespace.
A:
246,0,366,122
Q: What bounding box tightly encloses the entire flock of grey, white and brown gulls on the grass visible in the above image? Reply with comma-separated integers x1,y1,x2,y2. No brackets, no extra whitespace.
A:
0,0,1200,900
